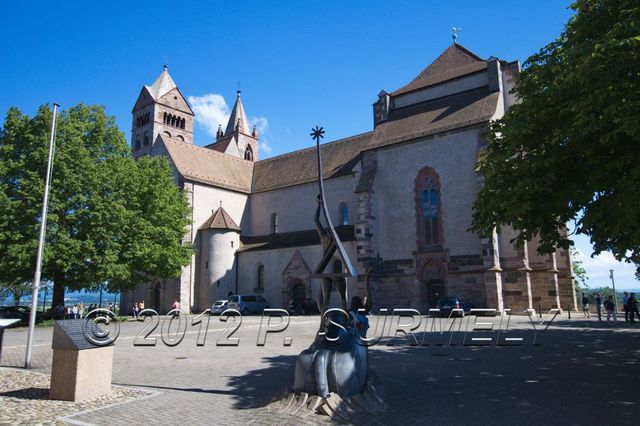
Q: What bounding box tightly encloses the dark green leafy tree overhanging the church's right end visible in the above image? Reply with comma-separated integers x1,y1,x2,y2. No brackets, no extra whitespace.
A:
473,0,640,273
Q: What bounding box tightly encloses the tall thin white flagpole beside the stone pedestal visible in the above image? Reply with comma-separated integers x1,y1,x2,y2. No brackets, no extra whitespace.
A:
24,103,59,368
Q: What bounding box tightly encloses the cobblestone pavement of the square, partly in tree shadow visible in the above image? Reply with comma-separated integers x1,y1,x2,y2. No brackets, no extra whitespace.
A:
0,315,640,425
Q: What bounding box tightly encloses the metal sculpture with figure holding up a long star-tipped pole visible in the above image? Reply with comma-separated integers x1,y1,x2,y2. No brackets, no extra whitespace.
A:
281,127,384,418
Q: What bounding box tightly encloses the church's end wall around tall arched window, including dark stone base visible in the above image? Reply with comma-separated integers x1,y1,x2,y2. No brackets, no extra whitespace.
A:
369,128,486,310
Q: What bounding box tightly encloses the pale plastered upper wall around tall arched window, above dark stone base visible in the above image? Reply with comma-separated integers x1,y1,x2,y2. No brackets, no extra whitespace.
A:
374,128,481,259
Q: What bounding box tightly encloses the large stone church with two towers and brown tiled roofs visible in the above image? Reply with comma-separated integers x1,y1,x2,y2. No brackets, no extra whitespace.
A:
121,43,576,312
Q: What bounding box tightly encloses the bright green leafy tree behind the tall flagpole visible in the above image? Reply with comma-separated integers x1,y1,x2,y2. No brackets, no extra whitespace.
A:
0,104,191,306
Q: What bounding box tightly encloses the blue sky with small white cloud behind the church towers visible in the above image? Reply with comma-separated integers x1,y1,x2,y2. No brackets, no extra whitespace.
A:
0,0,640,288
